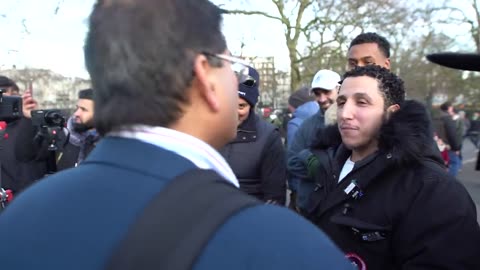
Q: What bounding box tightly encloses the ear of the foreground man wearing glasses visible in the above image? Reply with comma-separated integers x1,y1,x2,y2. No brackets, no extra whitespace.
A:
193,54,220,112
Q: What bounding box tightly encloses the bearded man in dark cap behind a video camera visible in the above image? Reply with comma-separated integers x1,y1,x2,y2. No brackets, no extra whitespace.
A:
16,89,100,174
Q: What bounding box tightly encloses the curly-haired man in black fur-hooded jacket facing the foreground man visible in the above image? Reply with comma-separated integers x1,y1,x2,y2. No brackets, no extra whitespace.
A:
288,65,480,269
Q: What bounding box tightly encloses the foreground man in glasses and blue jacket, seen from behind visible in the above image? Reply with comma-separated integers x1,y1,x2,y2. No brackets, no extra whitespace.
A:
0,0,351,270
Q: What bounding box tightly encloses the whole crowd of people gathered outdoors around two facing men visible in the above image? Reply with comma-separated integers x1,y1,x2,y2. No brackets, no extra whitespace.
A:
0,0,480,270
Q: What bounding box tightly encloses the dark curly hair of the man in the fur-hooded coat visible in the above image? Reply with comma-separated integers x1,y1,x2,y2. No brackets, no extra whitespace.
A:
342,65,405,107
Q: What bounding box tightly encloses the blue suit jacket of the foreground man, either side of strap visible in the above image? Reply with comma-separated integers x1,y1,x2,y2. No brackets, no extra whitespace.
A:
0,137,352,270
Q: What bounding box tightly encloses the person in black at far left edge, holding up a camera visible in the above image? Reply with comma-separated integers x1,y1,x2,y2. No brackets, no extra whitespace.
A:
0,76,46,193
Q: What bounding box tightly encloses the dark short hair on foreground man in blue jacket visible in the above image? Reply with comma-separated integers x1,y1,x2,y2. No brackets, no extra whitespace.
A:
85,0,226,135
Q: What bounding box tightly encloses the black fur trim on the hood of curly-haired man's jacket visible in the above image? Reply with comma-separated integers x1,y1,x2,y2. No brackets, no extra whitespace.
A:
312,100,443,166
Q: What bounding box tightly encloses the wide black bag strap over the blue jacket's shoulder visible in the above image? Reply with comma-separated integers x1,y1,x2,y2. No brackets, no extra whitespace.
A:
107,169,261,270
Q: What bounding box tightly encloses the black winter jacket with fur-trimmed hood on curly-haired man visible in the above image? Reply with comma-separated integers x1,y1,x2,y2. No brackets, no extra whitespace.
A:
290,101,480,269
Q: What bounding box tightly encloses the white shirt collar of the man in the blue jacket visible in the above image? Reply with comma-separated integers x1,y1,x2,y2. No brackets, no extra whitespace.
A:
107,125,240,187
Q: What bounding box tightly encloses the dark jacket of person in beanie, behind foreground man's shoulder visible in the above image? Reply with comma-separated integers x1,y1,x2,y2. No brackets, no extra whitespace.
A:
219,111,287,205
